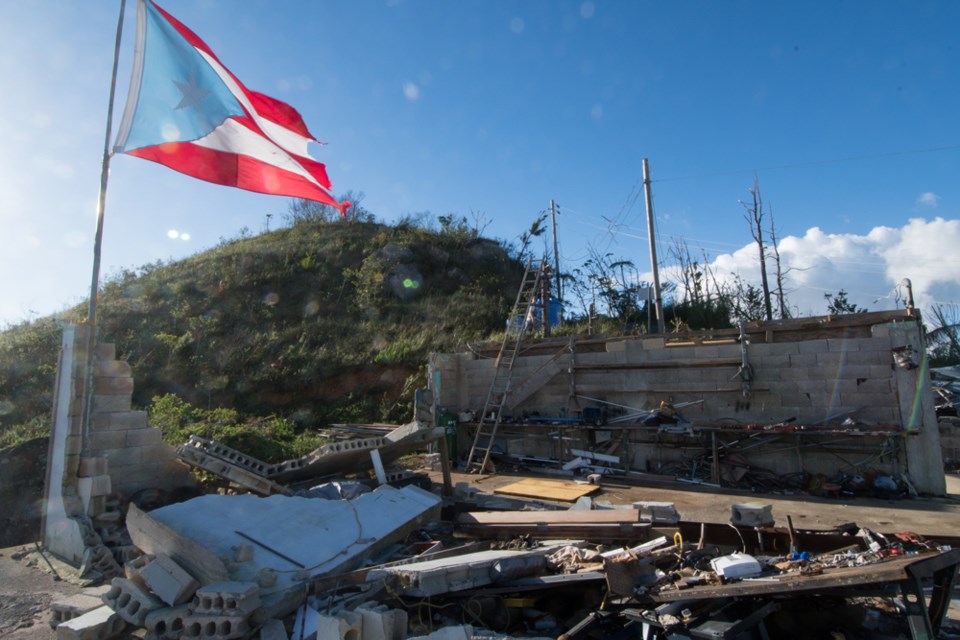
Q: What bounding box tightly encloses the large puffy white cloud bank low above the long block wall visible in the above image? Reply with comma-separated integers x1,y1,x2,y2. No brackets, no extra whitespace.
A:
665,217,960,315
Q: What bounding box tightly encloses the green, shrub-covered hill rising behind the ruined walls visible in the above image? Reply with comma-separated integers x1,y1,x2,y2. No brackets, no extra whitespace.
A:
0,220,523,448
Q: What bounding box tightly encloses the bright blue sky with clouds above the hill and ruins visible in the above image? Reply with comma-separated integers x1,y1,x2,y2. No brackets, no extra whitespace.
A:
0,0,960,326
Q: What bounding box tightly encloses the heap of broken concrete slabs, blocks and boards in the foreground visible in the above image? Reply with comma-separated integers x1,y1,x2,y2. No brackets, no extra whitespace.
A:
41,436,960,640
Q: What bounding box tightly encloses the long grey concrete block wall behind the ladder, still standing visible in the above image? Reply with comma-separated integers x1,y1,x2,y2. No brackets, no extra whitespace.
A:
430,311,946,494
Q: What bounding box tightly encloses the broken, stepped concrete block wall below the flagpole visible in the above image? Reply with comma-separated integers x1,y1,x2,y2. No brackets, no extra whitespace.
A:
41,324,195,564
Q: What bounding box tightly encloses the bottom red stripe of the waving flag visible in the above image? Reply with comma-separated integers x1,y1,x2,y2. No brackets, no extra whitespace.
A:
128,142,345,213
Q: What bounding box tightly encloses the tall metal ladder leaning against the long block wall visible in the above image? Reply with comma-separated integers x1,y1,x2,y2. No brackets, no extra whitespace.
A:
463,257,550,473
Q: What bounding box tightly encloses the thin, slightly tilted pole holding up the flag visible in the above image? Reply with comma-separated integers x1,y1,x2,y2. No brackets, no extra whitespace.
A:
81,0,127,453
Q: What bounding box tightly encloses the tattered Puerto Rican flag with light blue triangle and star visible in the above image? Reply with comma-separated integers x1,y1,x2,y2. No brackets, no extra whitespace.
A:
114,0,350,215
